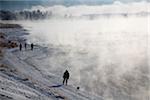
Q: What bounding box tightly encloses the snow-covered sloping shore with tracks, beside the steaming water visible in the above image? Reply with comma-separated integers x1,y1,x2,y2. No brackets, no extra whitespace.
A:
0,23,102,100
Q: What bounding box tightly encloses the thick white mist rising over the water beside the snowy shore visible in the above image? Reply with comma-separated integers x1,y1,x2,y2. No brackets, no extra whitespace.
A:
14,2,150,100
